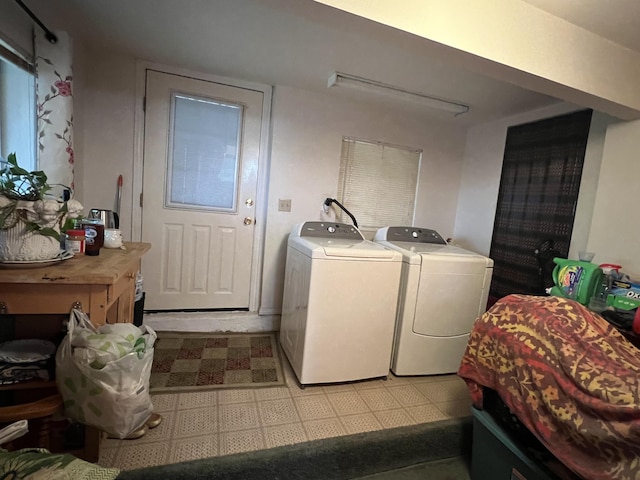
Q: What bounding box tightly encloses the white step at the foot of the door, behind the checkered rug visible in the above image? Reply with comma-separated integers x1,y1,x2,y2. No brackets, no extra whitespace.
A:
142,311,280,333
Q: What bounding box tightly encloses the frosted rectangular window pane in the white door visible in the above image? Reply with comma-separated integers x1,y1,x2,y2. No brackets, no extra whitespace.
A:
165,93,243,212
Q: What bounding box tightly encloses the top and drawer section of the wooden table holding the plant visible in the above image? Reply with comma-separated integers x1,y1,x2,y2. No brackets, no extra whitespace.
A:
0,243,151,326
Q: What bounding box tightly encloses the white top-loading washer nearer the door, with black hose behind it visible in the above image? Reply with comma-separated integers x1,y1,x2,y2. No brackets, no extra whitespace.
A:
280,222,402,385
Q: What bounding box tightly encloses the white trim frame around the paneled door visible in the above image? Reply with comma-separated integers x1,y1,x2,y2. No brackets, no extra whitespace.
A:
131,60,273,312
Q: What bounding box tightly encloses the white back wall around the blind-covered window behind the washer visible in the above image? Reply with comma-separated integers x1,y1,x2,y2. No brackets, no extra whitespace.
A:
260,87,466,314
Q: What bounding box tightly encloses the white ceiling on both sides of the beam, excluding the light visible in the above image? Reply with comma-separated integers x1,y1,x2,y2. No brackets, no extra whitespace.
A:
25,0,640,125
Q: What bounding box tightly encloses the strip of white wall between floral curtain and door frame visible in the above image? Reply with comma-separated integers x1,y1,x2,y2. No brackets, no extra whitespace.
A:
74,45,136,240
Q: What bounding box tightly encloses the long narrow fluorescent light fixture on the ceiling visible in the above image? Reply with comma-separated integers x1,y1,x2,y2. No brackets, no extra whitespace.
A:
327,72,469,116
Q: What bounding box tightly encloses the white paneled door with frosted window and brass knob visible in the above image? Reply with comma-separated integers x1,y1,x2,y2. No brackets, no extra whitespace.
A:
142,70,264,310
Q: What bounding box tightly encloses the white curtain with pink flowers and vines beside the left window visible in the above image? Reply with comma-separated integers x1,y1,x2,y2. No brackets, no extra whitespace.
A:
35,31,74,196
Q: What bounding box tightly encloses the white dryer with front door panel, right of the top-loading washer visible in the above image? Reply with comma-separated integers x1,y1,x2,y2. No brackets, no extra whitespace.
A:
374,227,493,375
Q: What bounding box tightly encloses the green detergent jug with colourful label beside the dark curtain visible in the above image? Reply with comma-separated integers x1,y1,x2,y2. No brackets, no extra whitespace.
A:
551,257,602,306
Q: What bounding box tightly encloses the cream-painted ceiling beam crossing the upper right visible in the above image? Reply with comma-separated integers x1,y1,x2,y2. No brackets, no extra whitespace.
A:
315,0,640,120
